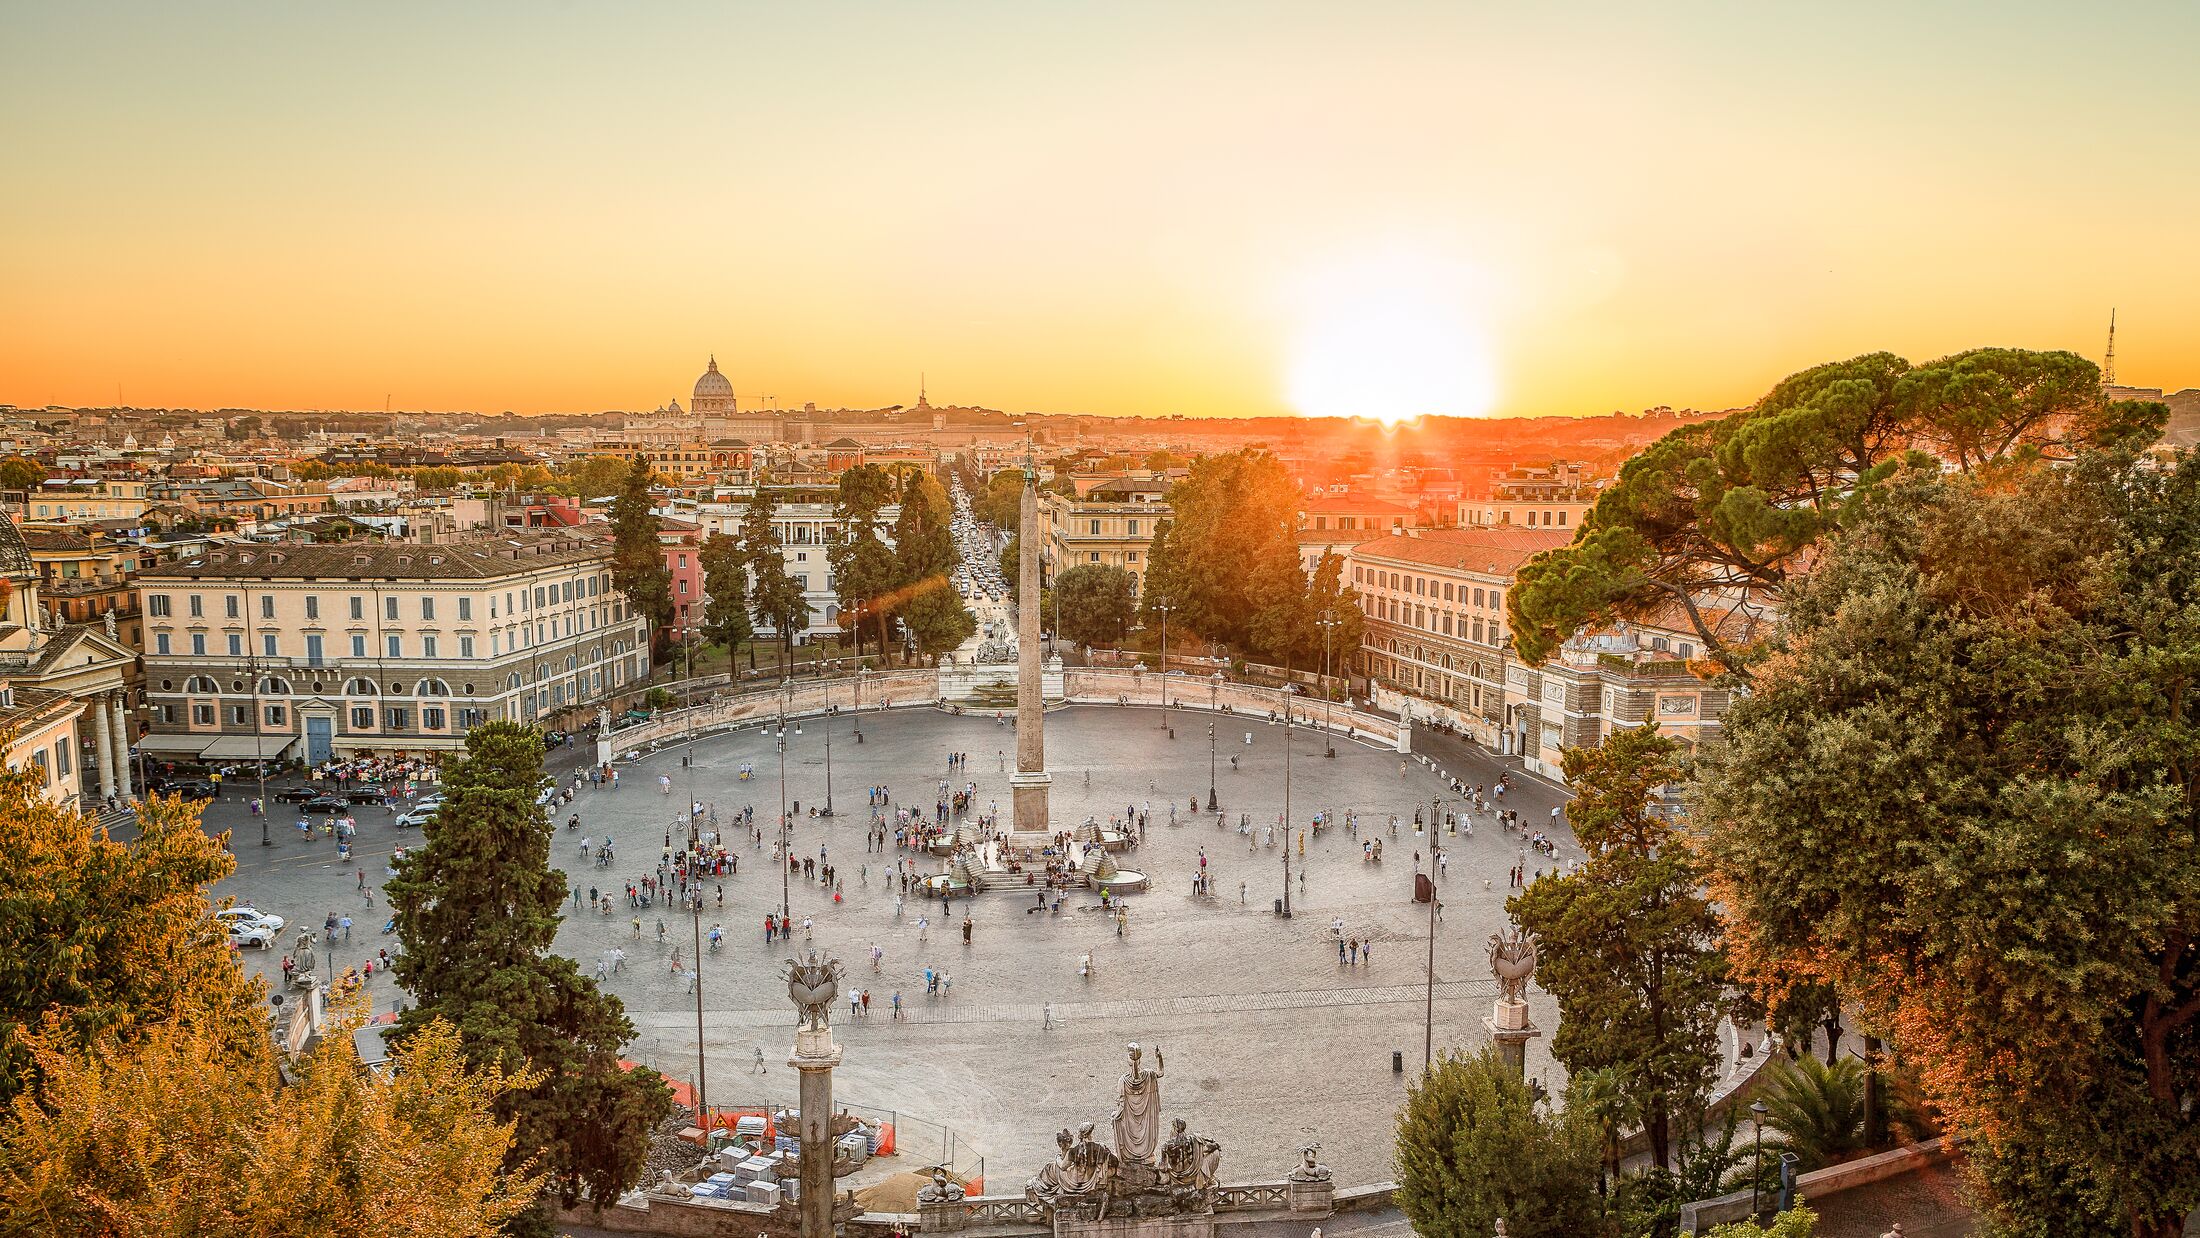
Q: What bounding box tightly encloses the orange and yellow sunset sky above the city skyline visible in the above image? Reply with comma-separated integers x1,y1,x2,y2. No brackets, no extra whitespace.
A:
0,0,2200,418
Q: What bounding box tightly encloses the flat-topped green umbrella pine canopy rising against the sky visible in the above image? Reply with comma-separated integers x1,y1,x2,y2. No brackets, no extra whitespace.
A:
1507,347,2169,673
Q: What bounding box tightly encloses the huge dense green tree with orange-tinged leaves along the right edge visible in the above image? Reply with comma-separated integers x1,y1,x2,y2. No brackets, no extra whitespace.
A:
1696,457,2200,1238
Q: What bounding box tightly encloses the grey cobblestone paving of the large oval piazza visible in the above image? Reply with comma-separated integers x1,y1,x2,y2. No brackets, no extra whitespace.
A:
209,706,1573,1190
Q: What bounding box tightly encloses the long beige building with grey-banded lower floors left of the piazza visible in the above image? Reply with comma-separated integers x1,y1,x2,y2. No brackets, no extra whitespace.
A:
139,532,649,761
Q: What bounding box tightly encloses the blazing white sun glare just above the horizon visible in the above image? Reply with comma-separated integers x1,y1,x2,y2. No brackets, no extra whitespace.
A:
1287,257,1496,427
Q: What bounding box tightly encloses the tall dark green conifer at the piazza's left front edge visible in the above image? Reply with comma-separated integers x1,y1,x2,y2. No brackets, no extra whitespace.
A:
385,721,671,1207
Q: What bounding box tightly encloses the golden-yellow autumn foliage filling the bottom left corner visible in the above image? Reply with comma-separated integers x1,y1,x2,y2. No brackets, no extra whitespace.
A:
0,998,539,1238
